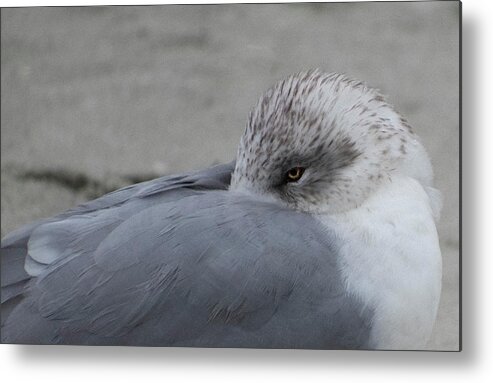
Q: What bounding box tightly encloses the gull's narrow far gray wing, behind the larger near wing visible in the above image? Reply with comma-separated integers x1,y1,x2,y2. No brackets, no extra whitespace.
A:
0,162,234,323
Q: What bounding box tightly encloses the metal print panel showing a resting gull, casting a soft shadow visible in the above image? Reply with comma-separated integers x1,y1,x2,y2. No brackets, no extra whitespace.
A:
1,2,460,350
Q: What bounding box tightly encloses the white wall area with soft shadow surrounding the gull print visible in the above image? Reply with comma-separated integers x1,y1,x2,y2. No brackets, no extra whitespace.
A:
0,0,493,383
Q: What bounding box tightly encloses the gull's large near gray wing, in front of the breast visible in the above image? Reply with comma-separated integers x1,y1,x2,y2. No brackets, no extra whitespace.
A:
2,168,371,349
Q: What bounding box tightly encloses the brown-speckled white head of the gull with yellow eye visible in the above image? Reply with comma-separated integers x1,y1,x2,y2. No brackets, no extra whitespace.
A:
231,70,432,213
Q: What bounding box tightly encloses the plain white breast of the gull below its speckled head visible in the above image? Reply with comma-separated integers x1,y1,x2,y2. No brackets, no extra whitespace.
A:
319,176,442,349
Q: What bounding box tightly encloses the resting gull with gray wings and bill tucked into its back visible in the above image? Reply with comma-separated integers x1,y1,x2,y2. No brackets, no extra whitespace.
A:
1,69,442,350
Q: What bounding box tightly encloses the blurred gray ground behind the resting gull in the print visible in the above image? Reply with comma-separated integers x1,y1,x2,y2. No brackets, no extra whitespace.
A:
1,1,460,350
